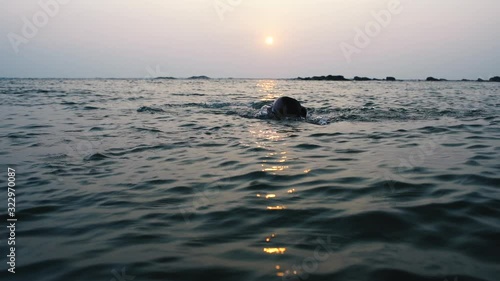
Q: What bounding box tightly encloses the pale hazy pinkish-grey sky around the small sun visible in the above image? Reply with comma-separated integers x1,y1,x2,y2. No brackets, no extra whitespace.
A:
0,0,500,79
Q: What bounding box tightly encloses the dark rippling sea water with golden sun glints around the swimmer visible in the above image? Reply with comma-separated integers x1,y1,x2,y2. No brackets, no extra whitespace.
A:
0,79,500,281
